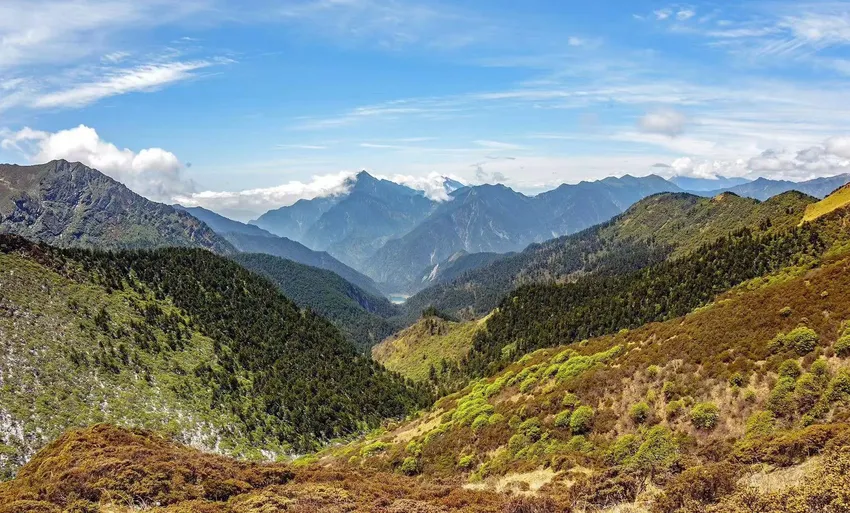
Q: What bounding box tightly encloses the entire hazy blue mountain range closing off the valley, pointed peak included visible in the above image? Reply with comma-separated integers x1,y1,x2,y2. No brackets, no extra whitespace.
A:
253,172,679,293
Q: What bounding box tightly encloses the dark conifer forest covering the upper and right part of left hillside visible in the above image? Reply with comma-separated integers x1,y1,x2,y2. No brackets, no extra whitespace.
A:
0,235,427,450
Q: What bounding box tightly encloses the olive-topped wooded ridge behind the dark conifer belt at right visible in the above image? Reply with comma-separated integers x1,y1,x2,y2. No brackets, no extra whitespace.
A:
405,192,816,322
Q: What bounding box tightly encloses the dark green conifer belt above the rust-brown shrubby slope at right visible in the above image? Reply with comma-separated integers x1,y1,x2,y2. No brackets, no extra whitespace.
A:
466,214,829,375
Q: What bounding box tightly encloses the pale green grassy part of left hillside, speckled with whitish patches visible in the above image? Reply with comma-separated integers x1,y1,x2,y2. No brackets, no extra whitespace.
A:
0,255,242,473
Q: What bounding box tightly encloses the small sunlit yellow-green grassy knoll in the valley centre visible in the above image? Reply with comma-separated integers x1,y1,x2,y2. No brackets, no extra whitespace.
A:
372,317,487,381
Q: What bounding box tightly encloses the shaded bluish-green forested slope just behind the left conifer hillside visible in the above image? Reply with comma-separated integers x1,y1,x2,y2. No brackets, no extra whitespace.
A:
232,253,399,352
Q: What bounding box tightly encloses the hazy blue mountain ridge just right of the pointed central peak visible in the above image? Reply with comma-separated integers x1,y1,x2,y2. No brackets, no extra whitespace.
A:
363,175,679,292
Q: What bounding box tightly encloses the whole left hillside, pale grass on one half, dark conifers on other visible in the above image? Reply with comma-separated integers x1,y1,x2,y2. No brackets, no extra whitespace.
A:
0,235,423,475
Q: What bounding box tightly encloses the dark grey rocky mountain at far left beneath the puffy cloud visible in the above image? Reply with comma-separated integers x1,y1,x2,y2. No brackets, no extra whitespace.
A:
0,160,233,253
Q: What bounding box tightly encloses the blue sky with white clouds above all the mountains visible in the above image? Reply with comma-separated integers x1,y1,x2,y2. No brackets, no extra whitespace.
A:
0,0,850,219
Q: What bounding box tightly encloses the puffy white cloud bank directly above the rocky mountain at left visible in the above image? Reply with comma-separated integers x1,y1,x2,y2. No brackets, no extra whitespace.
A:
0,125,194,202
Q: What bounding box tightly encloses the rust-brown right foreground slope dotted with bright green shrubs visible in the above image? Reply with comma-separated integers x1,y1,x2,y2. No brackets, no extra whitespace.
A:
334,240,850,505
